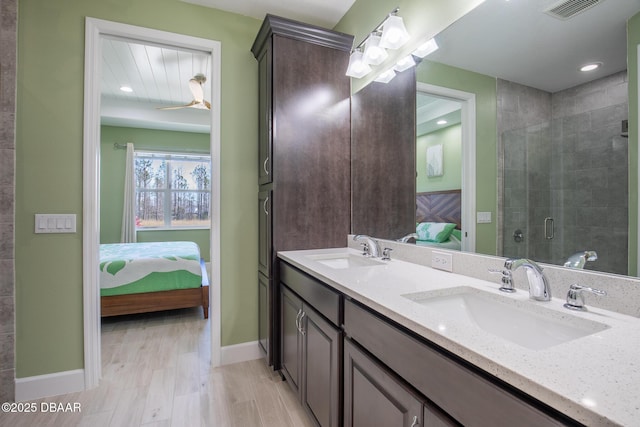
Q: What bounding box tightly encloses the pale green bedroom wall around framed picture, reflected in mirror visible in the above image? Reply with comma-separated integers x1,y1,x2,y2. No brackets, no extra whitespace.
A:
416,125,462,193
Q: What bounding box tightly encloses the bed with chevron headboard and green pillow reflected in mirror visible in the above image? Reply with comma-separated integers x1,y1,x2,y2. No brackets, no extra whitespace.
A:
416,190,462,250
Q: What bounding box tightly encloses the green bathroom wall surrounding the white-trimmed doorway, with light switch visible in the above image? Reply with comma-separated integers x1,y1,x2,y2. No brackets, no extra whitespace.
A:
15,0,261,378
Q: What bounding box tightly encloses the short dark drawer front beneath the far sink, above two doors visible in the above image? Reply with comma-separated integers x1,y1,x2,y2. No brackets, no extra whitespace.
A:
280,262,342,326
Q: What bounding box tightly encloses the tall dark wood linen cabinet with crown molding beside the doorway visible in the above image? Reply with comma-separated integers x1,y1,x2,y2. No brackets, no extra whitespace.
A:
251,15,353,369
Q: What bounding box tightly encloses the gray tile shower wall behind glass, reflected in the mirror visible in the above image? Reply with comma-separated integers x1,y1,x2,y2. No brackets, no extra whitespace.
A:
498,72,628,274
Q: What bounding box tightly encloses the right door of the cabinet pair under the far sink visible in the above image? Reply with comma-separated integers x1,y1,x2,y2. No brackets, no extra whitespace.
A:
301,304,342,427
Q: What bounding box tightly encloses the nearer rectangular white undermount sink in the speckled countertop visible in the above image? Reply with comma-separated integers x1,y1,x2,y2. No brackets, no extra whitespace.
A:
403,286,608,350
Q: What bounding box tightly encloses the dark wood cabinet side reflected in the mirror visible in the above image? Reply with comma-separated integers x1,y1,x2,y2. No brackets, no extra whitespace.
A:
351,68,416,239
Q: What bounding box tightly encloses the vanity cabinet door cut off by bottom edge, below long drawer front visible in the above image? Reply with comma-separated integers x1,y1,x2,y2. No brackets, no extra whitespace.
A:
344,339,423,427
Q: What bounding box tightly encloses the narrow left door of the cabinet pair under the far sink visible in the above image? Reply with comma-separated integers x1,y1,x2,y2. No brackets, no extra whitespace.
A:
280,286,302,393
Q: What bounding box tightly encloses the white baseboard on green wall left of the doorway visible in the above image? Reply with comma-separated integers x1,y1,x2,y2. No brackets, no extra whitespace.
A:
15,369,84,402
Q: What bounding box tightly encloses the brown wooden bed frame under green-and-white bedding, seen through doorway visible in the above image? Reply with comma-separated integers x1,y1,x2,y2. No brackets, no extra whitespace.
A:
100,261,209,319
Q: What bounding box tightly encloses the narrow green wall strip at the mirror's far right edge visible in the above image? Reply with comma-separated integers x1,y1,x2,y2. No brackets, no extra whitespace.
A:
627,13,640,276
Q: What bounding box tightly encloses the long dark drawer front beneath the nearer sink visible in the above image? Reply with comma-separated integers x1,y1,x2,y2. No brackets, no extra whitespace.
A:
344,300,580,427
